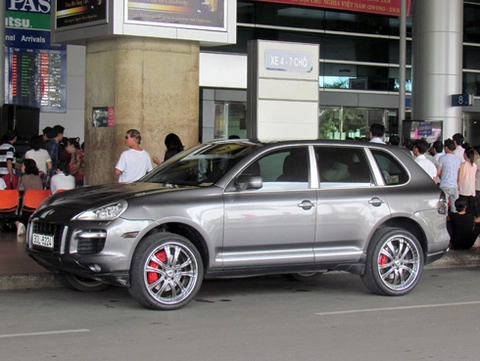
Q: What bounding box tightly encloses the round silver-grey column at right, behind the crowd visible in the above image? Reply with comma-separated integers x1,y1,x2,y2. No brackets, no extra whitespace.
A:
412,0,463,139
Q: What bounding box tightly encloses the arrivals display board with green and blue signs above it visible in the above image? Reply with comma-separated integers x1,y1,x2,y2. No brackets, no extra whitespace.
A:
4,0,67,112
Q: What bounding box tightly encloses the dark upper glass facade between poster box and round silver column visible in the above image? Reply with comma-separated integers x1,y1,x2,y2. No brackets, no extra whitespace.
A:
209,1,412,91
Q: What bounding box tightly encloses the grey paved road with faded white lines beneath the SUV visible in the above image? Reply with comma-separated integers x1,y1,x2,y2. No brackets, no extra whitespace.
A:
0,268,480,361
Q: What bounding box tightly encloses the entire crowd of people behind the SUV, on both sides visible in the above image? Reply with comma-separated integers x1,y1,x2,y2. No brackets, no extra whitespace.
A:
0,123,480,249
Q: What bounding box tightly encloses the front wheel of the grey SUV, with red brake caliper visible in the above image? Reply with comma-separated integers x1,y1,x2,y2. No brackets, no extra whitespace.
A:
128,233,203,310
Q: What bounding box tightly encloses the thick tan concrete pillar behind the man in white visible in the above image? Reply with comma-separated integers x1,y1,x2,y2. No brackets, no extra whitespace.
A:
85,36,199,185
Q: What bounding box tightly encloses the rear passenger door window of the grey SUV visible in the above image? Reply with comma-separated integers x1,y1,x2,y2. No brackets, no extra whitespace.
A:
315,147,371,188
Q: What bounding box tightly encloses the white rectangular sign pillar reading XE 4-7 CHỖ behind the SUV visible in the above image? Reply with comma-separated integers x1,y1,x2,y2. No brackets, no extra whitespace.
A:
247,40,319,141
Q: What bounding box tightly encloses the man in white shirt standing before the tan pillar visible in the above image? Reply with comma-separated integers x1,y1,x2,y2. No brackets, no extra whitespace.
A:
115,129,153,183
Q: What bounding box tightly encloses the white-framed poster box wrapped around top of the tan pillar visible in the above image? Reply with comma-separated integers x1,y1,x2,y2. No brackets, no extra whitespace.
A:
50,0,237,46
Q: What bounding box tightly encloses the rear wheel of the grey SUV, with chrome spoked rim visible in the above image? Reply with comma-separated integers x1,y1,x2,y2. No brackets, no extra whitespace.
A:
361,228,424,296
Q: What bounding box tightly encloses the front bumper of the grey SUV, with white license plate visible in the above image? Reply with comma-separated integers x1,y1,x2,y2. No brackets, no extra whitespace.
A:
26,218,151,286
